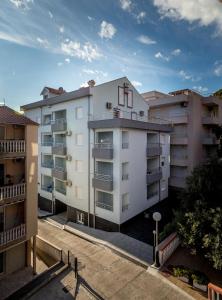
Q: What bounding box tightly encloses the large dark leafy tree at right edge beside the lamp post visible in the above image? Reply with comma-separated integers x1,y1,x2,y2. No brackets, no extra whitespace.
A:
175,159,222,270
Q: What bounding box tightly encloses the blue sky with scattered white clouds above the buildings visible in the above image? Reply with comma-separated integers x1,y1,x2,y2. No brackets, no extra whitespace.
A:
0,0,222,109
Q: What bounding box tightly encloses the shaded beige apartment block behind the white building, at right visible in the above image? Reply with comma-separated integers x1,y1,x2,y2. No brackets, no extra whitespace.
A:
142,89,222,188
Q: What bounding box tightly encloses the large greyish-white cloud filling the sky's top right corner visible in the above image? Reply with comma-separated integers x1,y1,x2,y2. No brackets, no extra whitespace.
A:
154,0,222,34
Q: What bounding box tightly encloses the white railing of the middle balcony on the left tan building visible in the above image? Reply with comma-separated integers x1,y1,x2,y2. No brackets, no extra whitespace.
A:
0,183,26,201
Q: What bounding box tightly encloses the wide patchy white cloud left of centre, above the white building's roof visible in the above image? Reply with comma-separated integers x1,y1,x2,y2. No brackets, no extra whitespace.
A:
61,40,103,62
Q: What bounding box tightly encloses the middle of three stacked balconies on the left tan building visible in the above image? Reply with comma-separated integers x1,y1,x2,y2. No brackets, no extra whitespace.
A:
0,183,26,205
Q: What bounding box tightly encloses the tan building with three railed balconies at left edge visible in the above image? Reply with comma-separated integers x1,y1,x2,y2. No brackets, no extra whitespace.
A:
0,106,38,279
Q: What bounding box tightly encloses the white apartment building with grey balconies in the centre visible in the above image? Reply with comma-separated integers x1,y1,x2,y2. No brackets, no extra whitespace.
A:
21,77,171,231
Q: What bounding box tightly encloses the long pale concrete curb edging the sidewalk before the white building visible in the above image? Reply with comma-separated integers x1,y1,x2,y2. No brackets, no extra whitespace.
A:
64,225,149,269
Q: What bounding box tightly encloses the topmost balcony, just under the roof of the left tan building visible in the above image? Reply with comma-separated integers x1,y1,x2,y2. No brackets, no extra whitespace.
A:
0,140,25,158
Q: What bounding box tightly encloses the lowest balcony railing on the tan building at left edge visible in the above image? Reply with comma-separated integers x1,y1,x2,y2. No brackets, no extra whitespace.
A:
0,224,26,246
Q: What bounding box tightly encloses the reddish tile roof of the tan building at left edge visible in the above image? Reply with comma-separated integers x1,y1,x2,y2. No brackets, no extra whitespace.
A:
0,105,38,126
